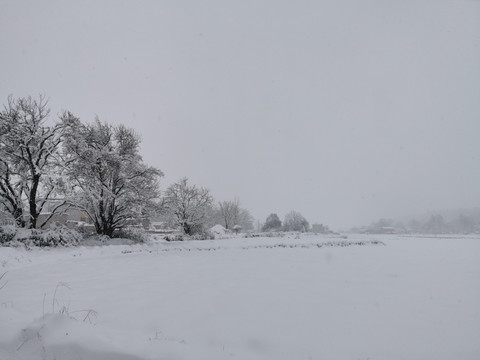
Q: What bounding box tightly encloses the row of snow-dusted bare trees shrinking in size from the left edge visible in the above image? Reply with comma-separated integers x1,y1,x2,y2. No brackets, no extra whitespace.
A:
0,96,253,237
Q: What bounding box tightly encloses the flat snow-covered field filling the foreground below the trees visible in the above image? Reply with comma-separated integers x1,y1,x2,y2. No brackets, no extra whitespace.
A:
0,235,480,360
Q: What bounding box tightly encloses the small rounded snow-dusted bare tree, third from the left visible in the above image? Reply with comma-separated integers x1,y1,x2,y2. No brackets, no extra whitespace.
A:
165,178,213,235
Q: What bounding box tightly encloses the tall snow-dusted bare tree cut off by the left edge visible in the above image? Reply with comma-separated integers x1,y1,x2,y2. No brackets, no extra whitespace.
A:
0,96,63,228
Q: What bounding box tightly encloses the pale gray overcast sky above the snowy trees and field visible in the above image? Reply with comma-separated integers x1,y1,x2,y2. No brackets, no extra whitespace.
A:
0,0,480,228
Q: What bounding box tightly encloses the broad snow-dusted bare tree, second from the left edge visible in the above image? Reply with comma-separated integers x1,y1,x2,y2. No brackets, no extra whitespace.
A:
62,113,163,237
